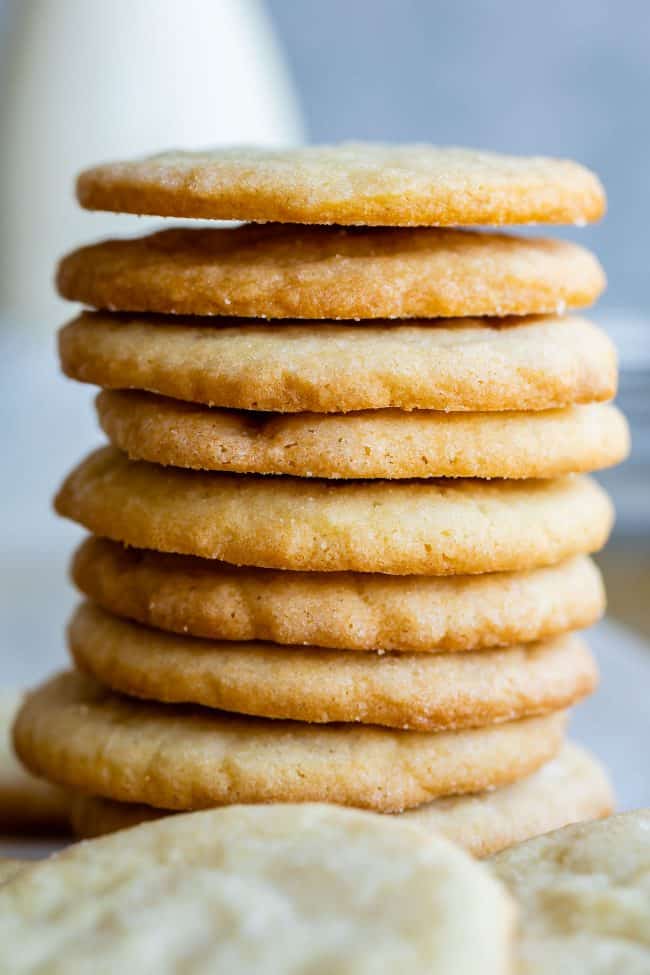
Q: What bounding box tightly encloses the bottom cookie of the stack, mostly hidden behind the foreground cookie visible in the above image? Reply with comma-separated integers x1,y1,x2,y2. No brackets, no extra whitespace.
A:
70,743,614,857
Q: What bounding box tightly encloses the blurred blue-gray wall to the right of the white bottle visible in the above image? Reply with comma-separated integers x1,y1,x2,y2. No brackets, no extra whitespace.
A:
267,0,650,314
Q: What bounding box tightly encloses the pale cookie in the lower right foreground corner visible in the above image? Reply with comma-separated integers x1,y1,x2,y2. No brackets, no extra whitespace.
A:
491,809,650,975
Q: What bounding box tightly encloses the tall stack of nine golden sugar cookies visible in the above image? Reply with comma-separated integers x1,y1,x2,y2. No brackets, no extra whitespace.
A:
15,144,628,854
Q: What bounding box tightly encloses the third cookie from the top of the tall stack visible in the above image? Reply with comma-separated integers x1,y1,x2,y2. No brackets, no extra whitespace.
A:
59,312,617,413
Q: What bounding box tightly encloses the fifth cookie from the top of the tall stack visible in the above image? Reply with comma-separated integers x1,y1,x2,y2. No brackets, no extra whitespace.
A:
55,447,613,575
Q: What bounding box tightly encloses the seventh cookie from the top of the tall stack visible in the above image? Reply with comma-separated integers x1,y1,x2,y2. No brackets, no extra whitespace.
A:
68,603,598,731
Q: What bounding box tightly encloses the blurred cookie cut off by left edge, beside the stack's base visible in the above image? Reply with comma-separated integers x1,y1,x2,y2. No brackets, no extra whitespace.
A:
0,688,68,836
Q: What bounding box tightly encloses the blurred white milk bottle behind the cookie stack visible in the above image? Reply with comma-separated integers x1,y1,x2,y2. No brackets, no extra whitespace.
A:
0,0,302,329
